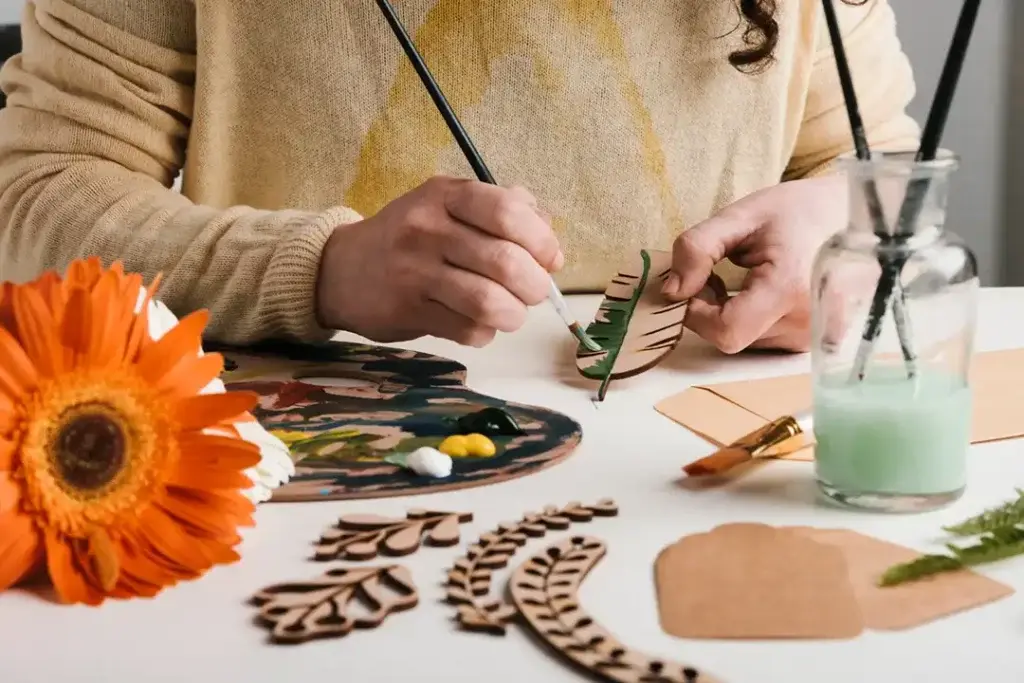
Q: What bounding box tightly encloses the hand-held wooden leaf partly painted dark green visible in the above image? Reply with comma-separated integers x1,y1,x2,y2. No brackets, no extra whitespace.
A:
577,250,688,400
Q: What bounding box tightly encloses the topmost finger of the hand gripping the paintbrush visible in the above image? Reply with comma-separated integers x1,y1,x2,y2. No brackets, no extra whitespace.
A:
444,181,565,272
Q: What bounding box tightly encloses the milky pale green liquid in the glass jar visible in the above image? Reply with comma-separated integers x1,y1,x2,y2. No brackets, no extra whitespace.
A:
814,368,971,496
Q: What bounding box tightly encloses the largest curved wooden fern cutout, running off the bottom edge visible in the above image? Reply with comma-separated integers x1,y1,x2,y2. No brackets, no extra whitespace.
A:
509,537,721,683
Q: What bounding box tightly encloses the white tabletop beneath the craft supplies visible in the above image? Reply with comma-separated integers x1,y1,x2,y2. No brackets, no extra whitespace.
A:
0,289,1024,683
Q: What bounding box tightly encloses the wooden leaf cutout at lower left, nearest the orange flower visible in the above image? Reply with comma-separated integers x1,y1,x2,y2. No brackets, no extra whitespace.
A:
252,565,419,643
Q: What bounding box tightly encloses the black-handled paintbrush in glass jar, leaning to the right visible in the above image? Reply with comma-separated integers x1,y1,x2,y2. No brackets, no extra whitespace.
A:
853,0,981,380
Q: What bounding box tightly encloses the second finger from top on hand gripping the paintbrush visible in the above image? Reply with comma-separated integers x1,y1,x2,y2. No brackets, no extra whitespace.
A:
441,220,551,306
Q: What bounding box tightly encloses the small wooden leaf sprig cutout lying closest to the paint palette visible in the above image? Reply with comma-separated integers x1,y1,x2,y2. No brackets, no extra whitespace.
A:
313,510,473,561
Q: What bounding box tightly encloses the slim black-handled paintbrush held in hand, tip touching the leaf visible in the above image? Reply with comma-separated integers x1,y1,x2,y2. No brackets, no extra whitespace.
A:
377,0,603,351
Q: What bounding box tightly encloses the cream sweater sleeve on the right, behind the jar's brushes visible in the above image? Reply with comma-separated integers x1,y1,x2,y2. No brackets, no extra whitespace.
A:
783,0,920,180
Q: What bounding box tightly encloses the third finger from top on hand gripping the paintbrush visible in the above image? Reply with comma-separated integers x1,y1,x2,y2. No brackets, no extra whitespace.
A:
430,265,526,332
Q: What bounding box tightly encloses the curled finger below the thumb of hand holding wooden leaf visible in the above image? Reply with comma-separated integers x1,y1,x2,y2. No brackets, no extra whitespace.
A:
687,270,792,353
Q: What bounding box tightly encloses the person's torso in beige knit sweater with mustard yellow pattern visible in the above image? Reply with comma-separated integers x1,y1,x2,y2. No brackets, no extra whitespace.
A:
183,0,817,291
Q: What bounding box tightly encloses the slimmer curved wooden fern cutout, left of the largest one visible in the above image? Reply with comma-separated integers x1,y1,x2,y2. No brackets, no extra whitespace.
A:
445,500,618,636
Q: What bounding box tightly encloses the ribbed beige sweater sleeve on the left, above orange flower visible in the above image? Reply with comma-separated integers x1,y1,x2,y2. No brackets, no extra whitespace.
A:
0,0,359,344
